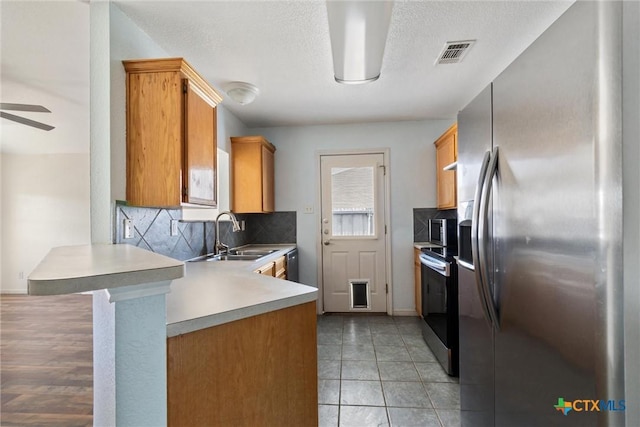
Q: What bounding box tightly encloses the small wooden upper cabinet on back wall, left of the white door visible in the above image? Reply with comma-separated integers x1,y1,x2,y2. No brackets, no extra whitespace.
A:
231,136,276,213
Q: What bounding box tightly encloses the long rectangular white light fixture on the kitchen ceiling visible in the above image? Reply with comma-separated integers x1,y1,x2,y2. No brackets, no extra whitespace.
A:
327,0,393,84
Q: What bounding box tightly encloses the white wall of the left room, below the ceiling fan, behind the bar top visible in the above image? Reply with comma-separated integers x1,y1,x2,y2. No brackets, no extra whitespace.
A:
1,153,90,293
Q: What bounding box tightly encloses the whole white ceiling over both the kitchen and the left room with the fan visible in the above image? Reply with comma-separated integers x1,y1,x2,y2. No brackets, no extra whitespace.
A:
0,0,572,153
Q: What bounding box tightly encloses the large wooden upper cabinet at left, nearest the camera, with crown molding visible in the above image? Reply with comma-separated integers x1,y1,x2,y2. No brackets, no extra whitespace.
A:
123,58,222,207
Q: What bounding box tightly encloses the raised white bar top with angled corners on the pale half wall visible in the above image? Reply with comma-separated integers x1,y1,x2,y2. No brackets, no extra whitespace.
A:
27,244,184,295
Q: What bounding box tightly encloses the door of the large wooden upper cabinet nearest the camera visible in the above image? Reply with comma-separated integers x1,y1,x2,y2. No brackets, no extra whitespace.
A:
182,81,217,206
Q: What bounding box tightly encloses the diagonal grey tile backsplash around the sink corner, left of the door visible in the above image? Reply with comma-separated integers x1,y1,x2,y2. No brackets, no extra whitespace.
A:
113,202,296,261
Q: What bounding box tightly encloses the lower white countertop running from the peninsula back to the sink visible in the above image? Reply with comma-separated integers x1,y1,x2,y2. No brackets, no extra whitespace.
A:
167,245,318,337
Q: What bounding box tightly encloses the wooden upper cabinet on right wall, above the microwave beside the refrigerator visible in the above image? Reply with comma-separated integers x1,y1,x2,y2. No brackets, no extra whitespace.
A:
434,123,458,209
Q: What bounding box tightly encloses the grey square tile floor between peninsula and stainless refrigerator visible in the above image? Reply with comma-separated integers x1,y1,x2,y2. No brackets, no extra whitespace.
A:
318,315,460,427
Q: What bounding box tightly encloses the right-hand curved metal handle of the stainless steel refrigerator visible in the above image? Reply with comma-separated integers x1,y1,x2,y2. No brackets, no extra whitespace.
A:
477,147,500,331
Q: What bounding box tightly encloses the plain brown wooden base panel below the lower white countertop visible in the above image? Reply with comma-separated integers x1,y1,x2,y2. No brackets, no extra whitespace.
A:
167,301,318,427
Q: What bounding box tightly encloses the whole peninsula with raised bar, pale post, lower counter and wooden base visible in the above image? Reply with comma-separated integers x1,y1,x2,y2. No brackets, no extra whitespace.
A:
29,245,318,426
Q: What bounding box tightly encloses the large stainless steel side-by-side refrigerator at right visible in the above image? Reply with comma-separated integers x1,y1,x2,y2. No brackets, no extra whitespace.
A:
457,1,625,427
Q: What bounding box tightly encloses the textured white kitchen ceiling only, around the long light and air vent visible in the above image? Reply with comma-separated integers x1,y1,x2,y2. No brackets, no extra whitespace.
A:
115,0,571,127
